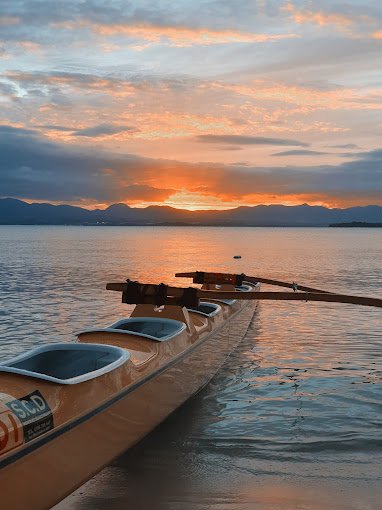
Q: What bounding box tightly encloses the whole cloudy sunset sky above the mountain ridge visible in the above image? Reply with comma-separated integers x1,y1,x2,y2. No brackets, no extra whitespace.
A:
0,0,382,209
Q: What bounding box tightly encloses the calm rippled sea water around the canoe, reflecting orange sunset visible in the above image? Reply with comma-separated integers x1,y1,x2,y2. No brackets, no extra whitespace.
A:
0,226,382,510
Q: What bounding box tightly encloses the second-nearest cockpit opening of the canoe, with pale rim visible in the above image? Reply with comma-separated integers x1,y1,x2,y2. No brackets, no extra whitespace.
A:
79,317,187,342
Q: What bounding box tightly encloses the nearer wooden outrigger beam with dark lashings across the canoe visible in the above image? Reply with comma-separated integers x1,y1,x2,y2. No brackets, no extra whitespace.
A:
106,280,382,308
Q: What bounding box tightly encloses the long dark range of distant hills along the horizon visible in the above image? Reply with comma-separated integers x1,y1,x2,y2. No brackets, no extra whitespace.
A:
0,198,382,227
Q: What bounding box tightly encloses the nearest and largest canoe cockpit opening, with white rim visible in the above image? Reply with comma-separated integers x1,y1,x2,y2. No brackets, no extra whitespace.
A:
0,343,130,384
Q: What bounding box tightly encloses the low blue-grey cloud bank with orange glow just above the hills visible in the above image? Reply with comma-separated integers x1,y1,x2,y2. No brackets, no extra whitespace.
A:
0,126,382,204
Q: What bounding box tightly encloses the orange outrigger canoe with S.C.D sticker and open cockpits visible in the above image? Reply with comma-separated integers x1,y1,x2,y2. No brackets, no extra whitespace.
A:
0,273,260,510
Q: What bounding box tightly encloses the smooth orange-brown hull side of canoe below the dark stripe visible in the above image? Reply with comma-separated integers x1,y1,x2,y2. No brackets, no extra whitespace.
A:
0,304,254,510
